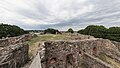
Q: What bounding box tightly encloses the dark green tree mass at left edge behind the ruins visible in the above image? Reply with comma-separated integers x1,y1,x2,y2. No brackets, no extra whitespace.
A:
0,24,27,38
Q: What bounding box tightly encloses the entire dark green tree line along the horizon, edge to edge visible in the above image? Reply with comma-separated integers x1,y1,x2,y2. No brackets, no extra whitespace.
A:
0,24,120,42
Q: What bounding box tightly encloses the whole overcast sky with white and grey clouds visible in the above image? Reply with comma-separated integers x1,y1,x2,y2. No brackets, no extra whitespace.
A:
0,0,120,30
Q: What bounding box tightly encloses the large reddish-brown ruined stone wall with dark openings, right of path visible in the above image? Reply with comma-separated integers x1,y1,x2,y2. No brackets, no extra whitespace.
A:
38,39,119,68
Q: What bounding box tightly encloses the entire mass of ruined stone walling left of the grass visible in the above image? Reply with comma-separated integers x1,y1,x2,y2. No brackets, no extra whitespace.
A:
0,34,32,68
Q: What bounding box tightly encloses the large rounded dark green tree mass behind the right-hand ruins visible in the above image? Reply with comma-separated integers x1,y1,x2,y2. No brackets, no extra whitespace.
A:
78,25,120,41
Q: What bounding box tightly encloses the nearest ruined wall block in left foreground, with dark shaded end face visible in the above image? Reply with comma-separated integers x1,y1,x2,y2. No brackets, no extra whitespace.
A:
0,43,29,68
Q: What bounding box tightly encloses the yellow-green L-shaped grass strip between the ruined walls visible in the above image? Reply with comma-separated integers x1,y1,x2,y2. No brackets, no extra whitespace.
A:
27,34,68,58
